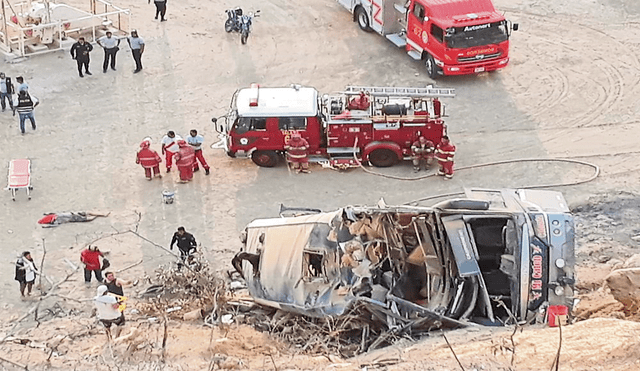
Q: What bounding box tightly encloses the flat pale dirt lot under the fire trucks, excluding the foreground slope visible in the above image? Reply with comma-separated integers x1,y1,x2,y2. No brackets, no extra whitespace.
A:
0,0,640,368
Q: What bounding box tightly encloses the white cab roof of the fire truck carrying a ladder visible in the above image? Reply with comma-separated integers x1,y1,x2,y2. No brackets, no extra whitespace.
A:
236,87,318,117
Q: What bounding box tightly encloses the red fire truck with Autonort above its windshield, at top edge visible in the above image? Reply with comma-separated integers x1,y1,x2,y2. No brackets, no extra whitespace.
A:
338,0,518,78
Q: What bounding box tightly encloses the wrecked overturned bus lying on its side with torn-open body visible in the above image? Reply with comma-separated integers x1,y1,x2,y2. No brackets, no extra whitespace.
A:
233,189,575,329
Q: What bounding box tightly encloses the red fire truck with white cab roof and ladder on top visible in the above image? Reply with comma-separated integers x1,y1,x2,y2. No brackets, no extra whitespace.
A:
212,84,455,168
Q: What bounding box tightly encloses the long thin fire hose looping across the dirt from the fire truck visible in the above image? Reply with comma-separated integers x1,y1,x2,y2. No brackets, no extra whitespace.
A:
353,138,600,205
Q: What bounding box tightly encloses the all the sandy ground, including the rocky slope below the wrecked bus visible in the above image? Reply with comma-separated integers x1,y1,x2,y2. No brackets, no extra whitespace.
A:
0,0,640,370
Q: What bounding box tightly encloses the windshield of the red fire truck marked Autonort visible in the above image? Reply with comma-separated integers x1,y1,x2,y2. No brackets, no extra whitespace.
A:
445,21,509,49
